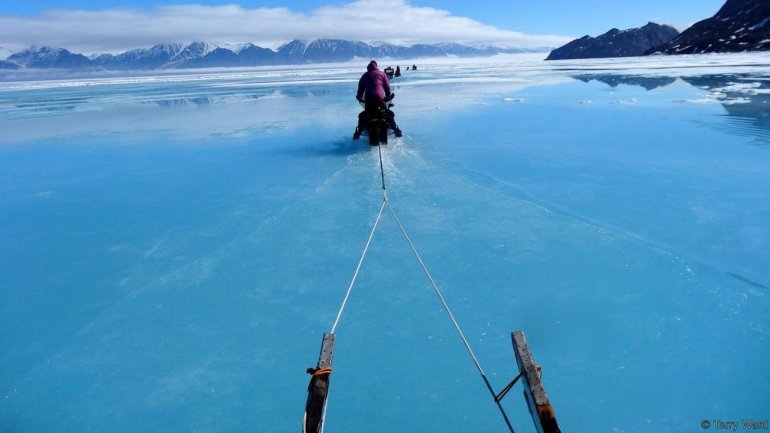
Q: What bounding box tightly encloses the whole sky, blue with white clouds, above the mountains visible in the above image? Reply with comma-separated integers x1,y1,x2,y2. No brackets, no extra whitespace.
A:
0,0,728,54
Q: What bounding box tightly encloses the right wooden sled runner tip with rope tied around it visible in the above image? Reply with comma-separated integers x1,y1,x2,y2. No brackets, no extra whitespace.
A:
511,331,561,433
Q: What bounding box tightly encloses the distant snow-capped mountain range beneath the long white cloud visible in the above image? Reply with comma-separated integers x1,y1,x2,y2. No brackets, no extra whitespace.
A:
0,39,526,70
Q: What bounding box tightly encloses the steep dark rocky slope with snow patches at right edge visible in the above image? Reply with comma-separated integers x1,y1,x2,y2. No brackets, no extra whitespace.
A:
647,0,770,54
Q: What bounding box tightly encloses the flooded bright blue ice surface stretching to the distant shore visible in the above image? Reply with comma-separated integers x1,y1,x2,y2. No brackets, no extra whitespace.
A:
0,55,770,433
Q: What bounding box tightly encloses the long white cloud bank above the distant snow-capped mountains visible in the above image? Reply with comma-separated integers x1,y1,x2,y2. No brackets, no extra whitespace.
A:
0,0,571,54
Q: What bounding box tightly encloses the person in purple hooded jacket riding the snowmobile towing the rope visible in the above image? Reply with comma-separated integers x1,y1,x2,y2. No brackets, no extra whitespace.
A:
353,60,401,140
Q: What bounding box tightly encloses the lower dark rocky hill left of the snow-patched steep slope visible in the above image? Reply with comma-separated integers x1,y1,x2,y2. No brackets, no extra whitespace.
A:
546,22,680,60
